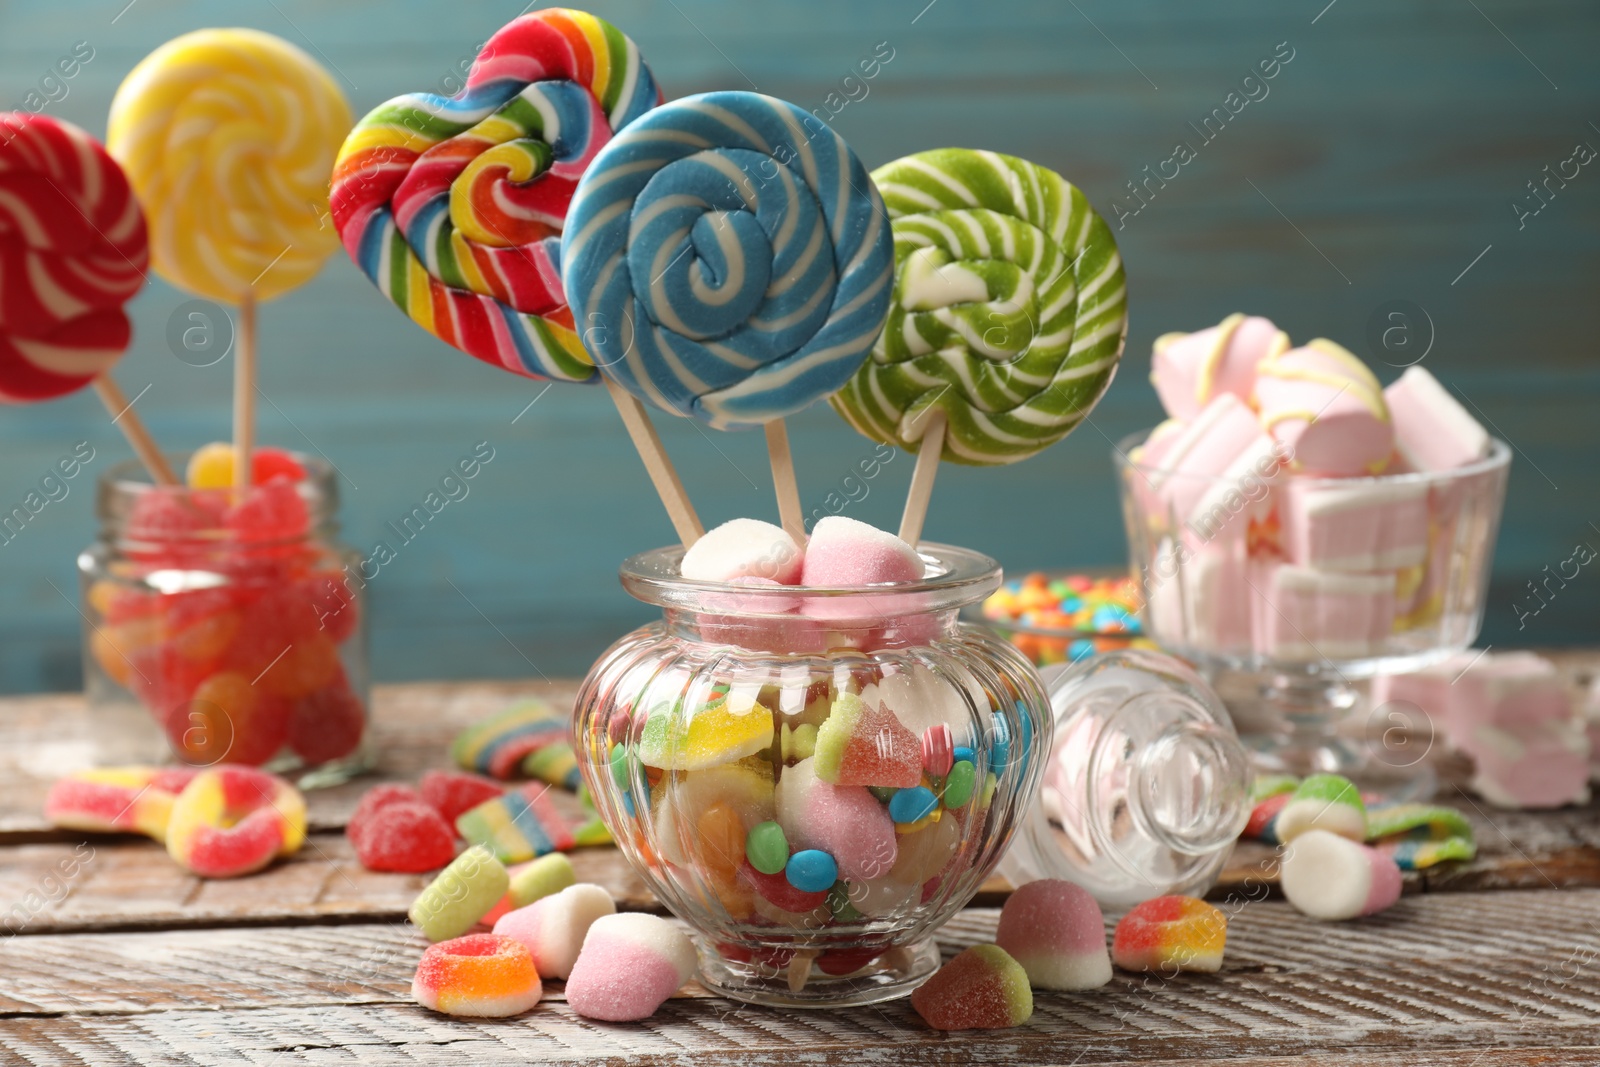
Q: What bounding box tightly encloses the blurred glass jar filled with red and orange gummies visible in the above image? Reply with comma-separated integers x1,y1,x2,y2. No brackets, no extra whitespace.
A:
78,456,371,787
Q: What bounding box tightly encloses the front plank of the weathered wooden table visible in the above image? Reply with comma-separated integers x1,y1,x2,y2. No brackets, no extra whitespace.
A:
0,891,1600,1065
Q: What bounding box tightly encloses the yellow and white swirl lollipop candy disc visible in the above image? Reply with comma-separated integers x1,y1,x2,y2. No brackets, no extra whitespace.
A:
106,29,350,302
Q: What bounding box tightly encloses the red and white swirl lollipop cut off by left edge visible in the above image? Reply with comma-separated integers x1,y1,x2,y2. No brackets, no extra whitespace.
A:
0,112,149,403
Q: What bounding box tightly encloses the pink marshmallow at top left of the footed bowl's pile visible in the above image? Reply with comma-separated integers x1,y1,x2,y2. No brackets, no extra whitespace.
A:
1150,312,1290,419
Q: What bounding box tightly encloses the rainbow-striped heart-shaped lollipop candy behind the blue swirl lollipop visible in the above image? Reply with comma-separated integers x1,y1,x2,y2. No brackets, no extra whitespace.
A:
333,8,661,381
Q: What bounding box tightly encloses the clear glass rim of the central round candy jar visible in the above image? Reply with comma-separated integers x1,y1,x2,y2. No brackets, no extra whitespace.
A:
619,541,1003,616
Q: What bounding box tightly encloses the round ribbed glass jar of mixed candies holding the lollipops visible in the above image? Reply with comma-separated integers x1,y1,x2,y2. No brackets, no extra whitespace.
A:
573,544,1051,1006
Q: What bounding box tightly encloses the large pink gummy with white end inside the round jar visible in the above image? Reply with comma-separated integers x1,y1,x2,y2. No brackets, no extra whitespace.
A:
776,760,898,881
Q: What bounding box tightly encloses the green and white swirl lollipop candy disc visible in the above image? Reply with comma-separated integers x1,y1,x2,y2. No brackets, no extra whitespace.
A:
830,149,1128,467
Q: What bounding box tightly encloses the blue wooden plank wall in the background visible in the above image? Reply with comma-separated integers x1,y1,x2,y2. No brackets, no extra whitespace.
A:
0,0,1600,691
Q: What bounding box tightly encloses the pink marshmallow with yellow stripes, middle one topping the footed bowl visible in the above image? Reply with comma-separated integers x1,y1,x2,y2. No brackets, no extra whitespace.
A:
1254,338,1395,477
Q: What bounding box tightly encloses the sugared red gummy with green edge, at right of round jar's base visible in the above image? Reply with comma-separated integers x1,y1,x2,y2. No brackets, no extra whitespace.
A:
995,878,1110,992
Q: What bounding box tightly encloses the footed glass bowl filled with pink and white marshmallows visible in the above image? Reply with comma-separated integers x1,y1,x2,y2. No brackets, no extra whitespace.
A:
1117,434,1510,798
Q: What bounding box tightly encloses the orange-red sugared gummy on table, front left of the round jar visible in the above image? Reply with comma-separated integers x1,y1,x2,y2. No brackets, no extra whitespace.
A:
411,934,544,1019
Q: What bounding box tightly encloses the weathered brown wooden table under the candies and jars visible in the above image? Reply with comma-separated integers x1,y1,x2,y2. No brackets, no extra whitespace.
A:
0,671,1600,1067
